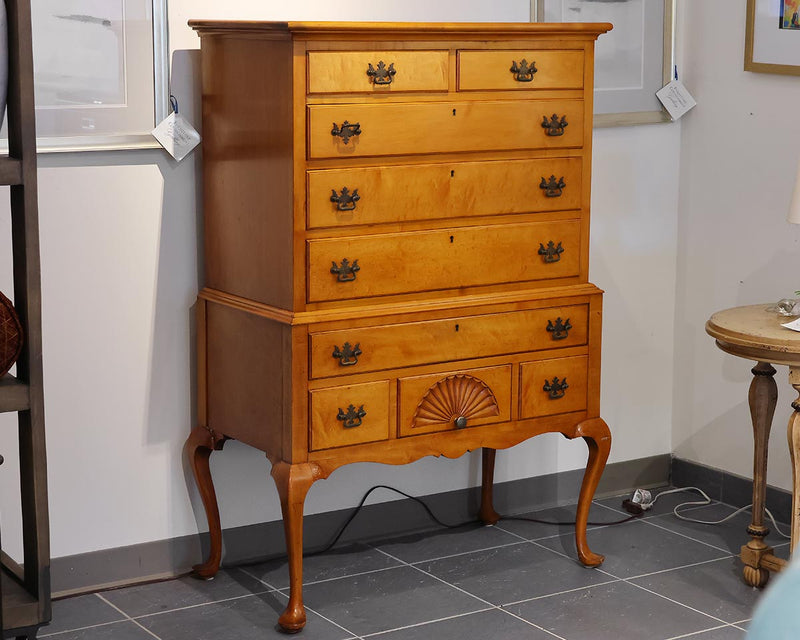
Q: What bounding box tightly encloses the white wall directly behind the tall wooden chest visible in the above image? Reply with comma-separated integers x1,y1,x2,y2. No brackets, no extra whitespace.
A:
0,0,680,557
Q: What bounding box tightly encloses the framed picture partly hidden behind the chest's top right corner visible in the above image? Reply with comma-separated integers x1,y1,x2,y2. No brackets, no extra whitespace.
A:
531,0,675,127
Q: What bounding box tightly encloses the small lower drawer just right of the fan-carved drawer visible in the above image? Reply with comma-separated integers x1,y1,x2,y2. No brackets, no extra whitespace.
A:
520,356,589,418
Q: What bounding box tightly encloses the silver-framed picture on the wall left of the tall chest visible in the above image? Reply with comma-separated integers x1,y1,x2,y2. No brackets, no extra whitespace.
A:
10,0,169,152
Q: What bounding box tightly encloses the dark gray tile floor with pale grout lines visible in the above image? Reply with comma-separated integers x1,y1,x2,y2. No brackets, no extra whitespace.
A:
39,494,788,640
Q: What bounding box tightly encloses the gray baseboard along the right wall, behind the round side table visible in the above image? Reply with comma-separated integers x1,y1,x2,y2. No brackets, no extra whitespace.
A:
670,458,792,523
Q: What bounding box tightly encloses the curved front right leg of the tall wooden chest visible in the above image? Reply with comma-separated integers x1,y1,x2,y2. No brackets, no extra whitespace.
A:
571,418,611,567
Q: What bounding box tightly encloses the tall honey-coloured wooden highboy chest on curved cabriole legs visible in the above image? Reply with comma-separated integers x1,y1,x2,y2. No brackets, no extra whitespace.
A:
187,21,611,630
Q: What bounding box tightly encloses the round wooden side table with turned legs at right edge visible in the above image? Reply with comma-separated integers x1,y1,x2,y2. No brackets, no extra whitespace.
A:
706,304,800,587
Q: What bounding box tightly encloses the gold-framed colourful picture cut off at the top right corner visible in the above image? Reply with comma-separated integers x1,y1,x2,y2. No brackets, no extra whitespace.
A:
744,0,800,76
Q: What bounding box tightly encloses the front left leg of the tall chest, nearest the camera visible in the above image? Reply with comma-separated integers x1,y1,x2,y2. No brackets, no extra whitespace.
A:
272,462,322,633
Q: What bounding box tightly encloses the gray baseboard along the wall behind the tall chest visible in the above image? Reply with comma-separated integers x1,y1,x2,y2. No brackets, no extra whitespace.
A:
51,454,672,597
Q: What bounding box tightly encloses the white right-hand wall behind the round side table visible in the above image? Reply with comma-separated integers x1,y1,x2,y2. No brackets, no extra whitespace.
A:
673,0,800,489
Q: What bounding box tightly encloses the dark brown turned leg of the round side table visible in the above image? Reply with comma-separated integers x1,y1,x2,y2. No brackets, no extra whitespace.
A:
741,362,778,587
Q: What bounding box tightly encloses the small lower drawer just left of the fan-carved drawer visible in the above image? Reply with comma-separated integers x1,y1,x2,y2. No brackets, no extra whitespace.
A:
310,381,389,451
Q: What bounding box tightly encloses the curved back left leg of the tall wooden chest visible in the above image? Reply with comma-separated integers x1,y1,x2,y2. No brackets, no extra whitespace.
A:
186,426,227,578
